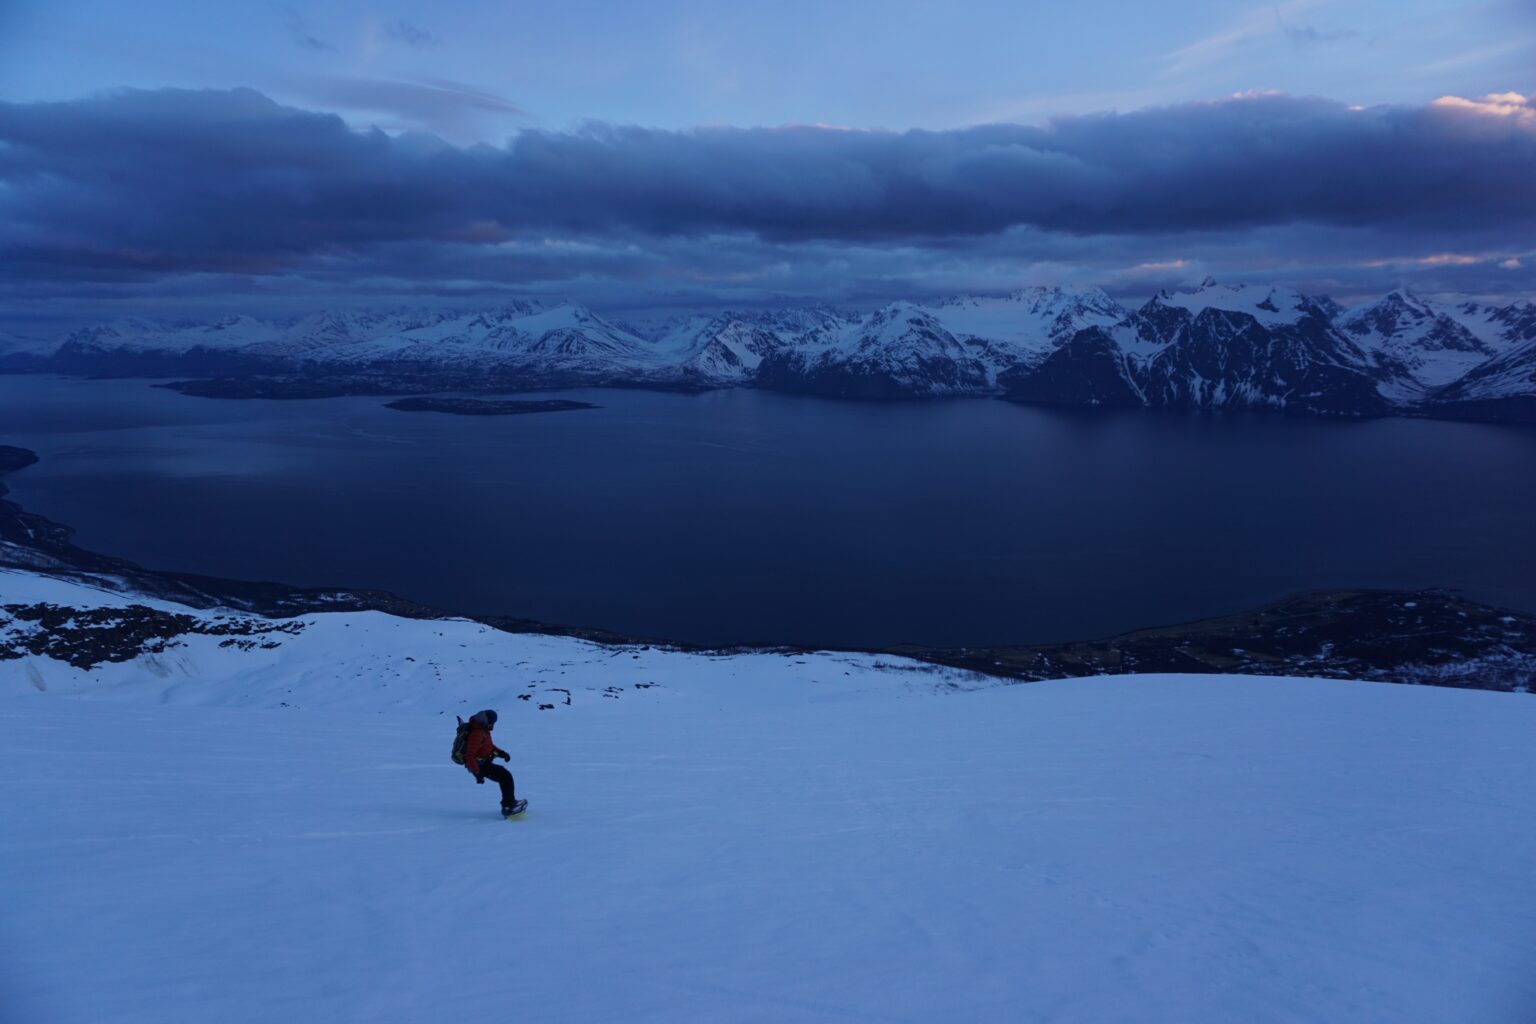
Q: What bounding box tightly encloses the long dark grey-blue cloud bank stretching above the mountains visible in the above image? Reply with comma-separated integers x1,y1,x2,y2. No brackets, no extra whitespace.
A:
0,89,1536,316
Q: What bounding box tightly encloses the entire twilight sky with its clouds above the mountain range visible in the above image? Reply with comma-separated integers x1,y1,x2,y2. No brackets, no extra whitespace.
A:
0,0,1536,322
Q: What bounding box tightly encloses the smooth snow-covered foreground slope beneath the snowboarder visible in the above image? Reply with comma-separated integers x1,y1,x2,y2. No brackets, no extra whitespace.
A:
9,573,1536,1024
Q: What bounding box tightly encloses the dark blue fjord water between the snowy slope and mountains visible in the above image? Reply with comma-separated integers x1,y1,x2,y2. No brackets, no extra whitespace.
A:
0,376,1536,646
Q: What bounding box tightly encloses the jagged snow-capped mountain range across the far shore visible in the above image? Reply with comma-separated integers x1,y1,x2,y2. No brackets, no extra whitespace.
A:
9,279,1536,421
